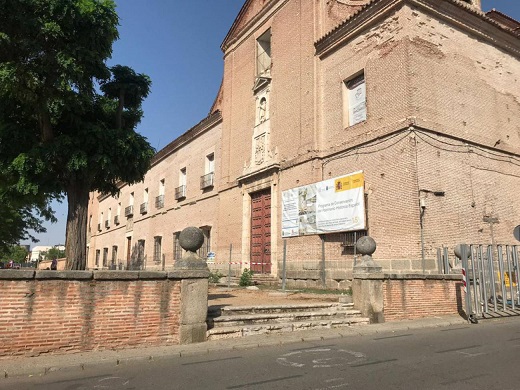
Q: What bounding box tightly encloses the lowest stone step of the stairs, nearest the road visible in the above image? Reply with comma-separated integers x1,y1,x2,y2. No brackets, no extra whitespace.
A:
207,317,370,340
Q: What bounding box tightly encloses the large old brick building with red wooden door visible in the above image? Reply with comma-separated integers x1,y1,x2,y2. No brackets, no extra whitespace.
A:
88,0,520,287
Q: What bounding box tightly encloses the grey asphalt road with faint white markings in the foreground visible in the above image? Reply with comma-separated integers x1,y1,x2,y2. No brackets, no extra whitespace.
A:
4,319,520,390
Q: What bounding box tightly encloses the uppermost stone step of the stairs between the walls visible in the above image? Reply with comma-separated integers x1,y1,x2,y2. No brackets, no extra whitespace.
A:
208,302,354,317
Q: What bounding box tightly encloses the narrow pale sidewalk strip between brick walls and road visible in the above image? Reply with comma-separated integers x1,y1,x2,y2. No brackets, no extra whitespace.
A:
0,316,472,383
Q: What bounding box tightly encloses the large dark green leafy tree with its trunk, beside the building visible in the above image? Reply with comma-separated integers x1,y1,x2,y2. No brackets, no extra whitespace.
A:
0,0,154,269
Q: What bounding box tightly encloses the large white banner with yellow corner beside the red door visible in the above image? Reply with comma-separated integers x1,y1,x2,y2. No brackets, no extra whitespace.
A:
282,171,366,237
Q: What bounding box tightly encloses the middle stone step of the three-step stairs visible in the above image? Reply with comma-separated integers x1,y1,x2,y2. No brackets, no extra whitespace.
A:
208,309,361,328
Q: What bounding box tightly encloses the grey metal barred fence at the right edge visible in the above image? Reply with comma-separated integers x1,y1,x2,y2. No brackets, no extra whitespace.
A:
461,245,520,322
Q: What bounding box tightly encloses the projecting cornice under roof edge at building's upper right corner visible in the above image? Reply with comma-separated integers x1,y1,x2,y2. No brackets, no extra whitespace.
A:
314,0,520,58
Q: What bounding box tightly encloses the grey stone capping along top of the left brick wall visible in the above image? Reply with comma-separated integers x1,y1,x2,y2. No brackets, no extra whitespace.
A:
0,269,209,280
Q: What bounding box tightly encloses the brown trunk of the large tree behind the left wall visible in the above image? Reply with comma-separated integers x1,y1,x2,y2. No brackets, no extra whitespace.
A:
65,183,89,270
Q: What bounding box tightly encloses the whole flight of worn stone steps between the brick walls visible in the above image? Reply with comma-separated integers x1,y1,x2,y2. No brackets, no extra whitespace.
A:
207,302,369,340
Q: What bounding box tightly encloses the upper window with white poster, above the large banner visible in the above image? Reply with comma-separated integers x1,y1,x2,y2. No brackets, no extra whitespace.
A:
343,73,367,127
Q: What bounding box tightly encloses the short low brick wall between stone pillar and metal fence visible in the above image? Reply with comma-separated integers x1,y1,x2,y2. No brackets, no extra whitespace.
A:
383,274,464,321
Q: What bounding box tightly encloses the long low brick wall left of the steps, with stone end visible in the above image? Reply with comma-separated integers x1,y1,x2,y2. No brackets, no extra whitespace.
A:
0,270,208,358
